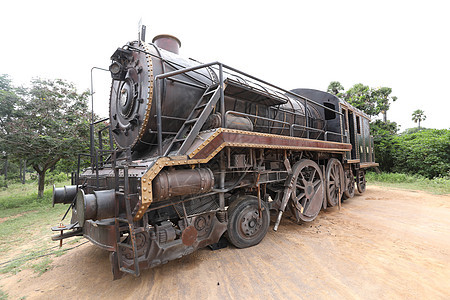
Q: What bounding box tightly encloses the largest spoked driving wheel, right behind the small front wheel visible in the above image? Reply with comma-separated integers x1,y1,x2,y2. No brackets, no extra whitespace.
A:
291,159,324,222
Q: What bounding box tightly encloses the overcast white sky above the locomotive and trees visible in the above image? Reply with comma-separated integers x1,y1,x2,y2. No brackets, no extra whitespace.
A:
0,0,450,130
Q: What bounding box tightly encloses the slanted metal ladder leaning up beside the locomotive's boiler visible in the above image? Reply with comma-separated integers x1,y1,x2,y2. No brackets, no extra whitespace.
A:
164,84,225,156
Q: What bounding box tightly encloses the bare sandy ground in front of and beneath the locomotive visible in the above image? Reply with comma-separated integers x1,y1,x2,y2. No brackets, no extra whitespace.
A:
0,186,450,299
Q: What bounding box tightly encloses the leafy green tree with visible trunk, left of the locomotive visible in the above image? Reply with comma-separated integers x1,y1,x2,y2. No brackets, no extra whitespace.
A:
0,79,89,197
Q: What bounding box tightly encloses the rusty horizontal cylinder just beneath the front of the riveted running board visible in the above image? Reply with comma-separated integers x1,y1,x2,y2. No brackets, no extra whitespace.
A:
153,168,214,201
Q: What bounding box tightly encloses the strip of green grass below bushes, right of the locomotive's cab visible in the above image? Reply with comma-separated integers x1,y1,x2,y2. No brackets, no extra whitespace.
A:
366,172,450,195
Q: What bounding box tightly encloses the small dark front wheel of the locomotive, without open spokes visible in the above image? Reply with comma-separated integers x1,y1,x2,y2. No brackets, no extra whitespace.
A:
227,195,270,248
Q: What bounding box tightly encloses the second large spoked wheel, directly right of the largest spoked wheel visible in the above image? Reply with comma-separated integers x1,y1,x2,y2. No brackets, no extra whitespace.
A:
325,158,344,206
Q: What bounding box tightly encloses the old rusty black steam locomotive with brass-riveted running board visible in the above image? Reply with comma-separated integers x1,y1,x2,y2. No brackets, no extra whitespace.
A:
52,31,378,279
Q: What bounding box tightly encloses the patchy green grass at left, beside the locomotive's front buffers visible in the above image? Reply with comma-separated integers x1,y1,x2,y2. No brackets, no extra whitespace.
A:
0,182,70,275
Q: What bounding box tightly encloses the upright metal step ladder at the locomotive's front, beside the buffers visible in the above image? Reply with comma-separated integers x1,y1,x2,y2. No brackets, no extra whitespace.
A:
114,163,140,276
